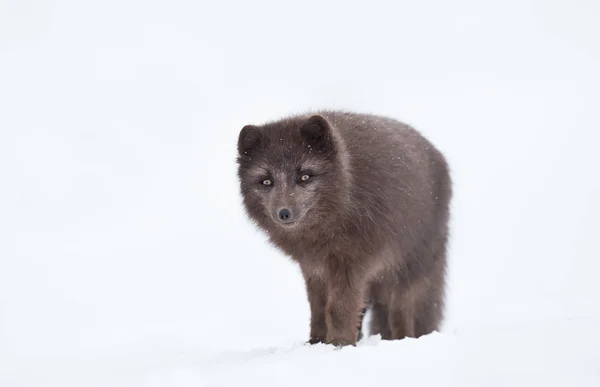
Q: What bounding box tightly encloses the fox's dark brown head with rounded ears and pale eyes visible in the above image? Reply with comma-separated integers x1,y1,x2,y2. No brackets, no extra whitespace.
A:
237,115,347,232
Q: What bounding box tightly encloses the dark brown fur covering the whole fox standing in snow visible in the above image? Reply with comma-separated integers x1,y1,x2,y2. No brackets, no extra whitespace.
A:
238,111,452,345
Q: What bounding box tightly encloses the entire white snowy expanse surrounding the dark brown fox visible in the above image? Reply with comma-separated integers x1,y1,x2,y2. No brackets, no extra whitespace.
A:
0,0,600,387
